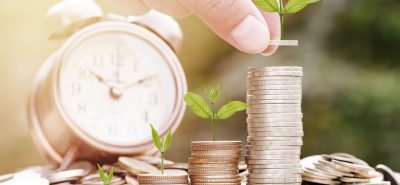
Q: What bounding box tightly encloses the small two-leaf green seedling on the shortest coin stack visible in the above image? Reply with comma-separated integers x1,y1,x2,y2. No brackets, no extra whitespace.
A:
150,124,171,174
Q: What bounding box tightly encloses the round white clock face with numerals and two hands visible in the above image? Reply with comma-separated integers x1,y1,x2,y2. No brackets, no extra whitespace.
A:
59,31,177,146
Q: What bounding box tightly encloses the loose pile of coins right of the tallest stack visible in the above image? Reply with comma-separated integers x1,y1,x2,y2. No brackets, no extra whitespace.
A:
301,153,390,185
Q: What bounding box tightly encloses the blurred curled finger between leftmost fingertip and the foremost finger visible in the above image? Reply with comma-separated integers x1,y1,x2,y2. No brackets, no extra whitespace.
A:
142,0,190,18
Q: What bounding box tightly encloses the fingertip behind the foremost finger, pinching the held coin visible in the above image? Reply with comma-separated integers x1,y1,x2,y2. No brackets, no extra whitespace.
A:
261,10,281,56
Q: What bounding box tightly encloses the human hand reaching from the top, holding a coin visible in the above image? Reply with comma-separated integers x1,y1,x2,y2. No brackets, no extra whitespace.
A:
109,0,280,55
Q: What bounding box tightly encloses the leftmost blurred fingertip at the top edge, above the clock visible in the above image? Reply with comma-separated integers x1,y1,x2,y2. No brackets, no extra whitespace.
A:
108,0,150,15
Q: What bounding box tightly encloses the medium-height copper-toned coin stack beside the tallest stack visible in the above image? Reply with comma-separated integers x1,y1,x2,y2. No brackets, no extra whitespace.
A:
189,141,241,185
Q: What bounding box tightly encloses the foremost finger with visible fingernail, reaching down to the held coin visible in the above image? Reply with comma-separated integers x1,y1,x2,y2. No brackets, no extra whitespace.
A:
180,0,269,53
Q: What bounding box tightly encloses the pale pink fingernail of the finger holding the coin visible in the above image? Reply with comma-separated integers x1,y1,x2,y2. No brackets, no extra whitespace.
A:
231,15,269,53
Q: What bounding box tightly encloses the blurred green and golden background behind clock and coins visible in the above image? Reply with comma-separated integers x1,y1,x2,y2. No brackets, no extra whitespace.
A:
0,0,400,173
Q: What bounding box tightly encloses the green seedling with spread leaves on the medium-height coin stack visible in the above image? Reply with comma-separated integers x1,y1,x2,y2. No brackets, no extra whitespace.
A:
184,87,247,141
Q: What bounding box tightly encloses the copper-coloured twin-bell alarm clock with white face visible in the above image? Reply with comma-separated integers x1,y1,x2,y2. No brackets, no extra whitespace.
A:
28,0,187,164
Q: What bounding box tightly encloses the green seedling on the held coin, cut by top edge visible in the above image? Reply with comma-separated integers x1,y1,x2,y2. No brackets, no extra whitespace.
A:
254,0,320,38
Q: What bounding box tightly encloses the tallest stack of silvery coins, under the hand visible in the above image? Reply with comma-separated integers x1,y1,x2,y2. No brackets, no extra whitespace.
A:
245,66,304,184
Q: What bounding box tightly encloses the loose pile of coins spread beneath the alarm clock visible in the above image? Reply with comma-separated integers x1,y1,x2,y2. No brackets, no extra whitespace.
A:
0,156,188,185
